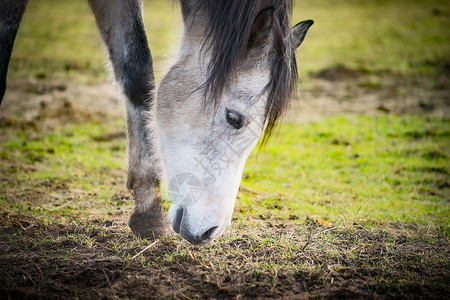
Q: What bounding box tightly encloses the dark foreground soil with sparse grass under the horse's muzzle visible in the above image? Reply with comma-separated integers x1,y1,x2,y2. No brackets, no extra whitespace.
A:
0,213,450,299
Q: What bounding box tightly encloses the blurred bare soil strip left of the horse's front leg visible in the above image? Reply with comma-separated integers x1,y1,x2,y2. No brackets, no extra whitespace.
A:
0,79,123,130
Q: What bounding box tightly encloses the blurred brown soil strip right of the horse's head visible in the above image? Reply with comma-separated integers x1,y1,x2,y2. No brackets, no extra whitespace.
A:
286,66,450,123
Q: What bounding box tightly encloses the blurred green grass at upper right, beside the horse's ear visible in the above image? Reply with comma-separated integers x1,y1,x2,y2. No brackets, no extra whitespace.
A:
293,0,450,73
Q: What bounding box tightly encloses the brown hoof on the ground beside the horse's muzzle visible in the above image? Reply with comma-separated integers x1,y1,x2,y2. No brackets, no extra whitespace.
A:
128,211,174,239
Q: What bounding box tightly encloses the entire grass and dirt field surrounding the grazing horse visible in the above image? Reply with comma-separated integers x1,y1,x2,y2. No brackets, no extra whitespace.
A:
0,0,450,299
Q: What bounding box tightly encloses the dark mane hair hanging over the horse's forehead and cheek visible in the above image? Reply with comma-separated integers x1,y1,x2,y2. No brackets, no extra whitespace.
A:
181,0,298,144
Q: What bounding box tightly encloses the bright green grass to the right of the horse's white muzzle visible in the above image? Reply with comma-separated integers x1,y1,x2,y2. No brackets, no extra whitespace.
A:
238,116,450,230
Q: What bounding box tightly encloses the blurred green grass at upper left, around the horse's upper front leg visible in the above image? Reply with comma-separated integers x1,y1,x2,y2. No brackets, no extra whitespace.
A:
9,0,182,82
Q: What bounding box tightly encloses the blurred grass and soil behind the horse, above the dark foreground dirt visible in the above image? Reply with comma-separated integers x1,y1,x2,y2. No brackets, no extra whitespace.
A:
0,0,450,230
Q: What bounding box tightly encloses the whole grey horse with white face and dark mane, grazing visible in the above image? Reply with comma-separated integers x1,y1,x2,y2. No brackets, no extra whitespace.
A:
0,0,313,243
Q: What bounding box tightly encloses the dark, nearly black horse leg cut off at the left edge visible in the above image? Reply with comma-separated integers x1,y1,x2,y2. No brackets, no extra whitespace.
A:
0,0,28,104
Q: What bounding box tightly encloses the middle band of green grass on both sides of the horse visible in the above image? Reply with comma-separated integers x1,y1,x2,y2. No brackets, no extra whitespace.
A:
1,116,450,234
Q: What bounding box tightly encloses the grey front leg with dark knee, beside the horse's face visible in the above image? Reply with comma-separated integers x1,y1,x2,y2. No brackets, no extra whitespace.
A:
89,0,171,237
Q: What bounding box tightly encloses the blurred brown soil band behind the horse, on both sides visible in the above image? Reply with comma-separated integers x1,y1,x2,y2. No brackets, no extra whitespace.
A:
0,66,450,127
